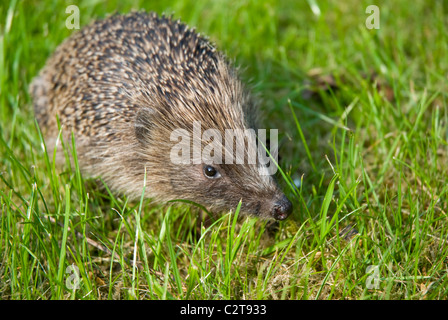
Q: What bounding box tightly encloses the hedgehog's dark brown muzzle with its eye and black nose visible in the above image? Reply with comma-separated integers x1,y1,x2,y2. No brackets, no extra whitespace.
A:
159,156,292,220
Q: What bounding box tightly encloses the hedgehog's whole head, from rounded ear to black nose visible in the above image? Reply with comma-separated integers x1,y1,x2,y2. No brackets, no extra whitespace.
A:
134,95,292,220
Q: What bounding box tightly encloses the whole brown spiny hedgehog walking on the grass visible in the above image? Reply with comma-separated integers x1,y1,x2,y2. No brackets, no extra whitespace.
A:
30,11,292,220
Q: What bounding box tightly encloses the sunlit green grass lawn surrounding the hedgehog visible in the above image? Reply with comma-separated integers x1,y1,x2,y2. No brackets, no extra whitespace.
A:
0,0,448,299
